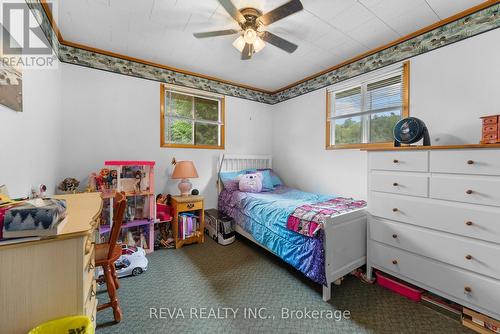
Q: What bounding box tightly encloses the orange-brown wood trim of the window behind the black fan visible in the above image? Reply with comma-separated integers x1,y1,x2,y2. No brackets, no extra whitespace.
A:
325,61,410,150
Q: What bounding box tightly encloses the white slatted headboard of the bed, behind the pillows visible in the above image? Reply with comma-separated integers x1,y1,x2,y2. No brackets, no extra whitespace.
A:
217,154,272,192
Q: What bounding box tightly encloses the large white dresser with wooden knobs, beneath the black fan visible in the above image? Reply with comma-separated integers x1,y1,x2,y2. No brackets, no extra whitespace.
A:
367,145,500,319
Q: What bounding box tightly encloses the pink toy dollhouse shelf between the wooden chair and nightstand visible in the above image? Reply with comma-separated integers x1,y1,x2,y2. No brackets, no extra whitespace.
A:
99,161,156,253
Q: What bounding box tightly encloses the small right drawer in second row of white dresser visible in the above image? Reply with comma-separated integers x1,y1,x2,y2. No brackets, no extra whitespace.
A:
430,175,500,206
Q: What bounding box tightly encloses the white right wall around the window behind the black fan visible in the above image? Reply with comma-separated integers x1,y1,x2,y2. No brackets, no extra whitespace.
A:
273,29,500,198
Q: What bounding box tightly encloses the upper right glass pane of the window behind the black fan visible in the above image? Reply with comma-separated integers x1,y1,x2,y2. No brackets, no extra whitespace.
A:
365,75,403,110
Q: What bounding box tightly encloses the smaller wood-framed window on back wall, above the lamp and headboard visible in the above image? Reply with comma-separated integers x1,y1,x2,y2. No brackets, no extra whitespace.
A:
160,84,224,149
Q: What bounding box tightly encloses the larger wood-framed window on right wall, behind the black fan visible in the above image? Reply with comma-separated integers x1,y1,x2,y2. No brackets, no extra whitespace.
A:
326,62,409,149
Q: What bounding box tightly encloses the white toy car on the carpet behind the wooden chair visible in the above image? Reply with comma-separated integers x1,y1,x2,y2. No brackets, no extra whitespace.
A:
96,245,148,285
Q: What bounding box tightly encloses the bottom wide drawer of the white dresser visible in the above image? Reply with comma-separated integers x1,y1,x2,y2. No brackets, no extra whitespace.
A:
368,242,500,317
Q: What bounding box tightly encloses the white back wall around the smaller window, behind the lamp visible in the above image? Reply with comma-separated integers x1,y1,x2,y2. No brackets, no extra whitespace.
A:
61,64,272,207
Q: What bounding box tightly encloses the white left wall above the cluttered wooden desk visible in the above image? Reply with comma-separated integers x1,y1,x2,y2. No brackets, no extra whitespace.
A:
0,64,62,197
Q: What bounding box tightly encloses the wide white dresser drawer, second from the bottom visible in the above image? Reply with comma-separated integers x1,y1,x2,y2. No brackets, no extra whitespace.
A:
369,219,500,279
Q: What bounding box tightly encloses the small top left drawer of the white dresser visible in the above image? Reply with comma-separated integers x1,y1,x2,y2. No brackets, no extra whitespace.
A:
368,151,429,172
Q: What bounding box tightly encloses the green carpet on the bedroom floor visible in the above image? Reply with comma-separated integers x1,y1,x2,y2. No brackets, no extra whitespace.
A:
97,239,472,334
